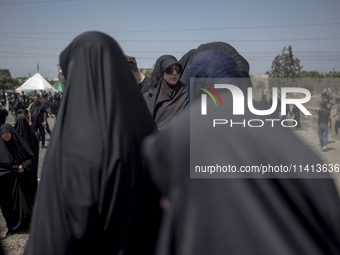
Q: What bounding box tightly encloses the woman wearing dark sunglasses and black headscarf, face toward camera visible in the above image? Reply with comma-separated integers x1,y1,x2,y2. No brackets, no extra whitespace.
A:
144,55,189,129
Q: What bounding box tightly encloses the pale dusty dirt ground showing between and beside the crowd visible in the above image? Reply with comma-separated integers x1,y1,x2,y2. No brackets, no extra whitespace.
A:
0,92,340,255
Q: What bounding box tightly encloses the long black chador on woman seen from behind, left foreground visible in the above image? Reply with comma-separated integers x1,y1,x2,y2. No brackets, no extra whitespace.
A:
25,32,160,255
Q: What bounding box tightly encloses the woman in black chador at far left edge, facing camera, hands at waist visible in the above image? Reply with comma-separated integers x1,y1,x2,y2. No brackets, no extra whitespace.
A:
0,123,37,235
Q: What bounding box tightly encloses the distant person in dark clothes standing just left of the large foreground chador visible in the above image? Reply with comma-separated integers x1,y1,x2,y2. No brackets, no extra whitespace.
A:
28,94,47,148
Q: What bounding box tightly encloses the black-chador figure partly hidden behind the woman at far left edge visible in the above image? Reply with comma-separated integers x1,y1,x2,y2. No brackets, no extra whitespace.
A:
14,110,39,170
